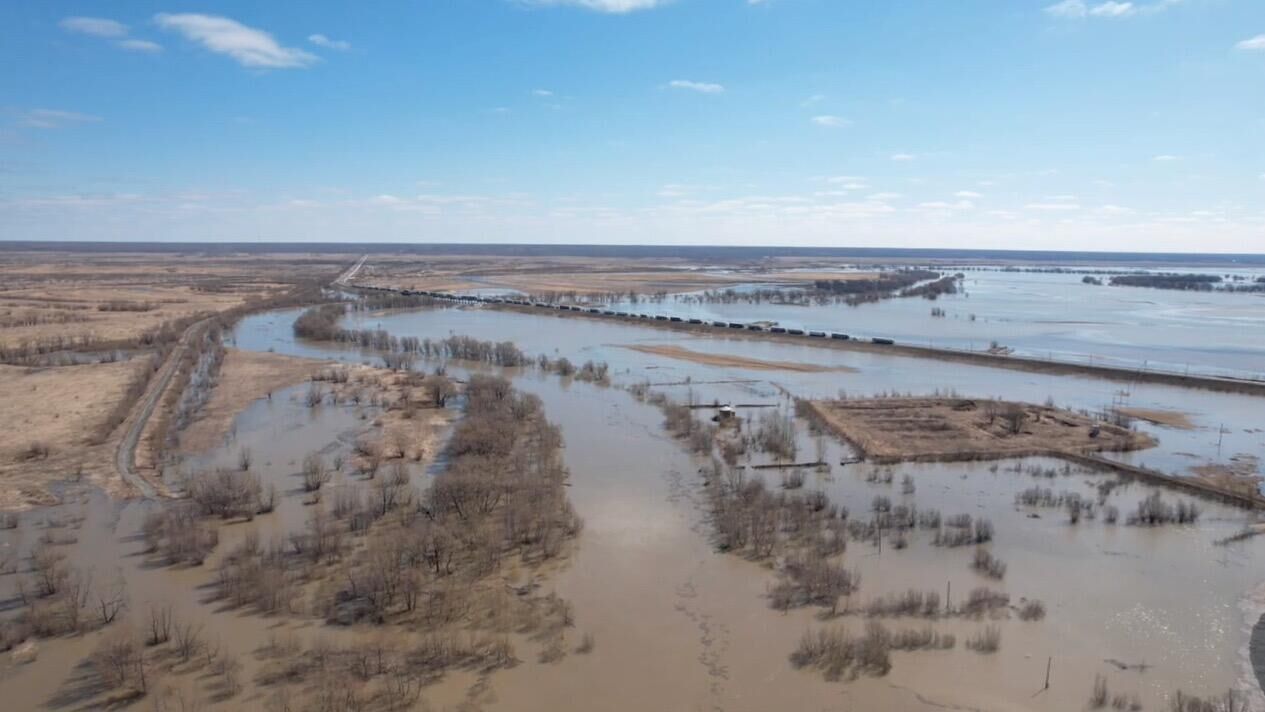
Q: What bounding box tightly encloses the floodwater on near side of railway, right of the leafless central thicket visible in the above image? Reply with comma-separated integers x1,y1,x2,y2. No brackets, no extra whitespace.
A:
238,309,1261,709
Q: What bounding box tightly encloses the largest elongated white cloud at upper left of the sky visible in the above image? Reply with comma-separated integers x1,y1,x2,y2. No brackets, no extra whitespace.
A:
154,13,318,70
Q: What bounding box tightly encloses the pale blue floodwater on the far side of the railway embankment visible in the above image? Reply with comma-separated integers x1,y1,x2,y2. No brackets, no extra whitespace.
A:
586,267,1265,378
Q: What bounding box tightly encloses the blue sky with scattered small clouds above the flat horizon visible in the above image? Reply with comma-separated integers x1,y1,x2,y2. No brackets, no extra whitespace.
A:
0,0,1265,253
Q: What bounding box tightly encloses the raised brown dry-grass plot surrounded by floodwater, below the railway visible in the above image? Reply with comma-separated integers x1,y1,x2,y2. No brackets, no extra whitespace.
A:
810,397,1155,463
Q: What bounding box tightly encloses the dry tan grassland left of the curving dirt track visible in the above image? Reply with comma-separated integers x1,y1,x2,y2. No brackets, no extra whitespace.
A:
0,250,355,507
